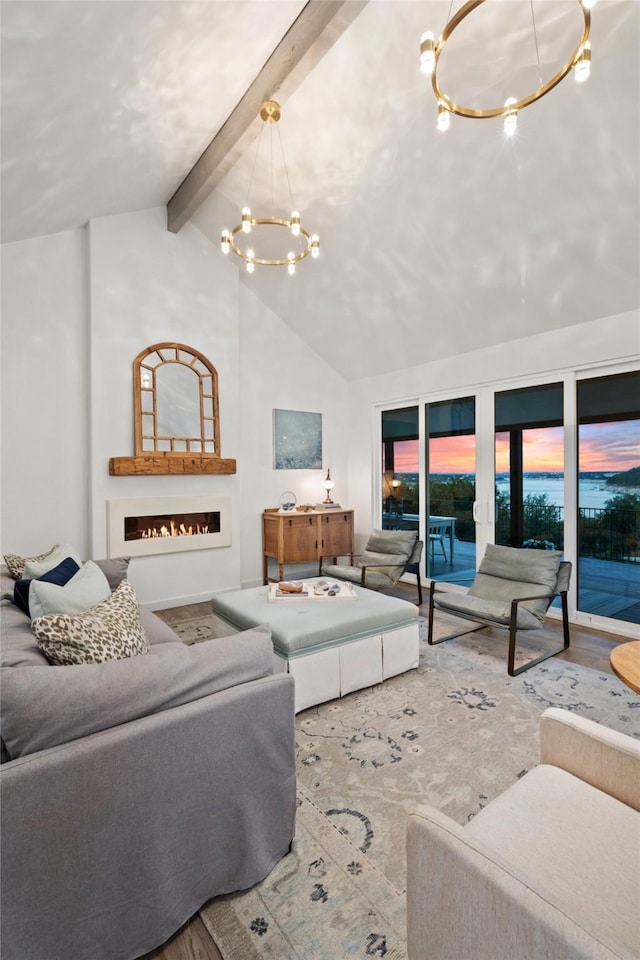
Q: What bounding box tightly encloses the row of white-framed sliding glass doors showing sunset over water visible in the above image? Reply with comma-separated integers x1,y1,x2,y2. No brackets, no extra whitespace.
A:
380,371,640,635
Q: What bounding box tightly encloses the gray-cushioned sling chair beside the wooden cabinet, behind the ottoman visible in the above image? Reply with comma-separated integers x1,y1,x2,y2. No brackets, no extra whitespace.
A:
318,530,424,605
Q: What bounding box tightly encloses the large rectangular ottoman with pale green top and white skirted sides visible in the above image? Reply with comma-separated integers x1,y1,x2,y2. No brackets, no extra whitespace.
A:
211,581,420,713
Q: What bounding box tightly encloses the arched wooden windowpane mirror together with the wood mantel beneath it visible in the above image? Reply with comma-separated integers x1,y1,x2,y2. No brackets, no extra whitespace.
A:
110,343,236,476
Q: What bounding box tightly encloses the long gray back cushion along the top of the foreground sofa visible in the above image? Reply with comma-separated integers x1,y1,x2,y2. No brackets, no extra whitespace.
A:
0,626,273,759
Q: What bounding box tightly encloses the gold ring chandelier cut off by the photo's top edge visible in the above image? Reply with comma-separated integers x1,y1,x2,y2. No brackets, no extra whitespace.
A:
420,0,596,137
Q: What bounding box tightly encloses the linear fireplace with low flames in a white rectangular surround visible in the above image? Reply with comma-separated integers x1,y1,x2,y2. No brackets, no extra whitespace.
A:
107,496,231,557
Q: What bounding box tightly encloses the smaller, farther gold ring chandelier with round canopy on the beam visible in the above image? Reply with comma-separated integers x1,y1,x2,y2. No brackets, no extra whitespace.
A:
220,100,320,276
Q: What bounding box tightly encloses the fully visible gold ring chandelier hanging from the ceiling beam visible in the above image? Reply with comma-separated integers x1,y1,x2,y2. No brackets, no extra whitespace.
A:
220,100,320,276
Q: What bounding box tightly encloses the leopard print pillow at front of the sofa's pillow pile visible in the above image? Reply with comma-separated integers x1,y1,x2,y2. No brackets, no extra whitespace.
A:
31,580,150,666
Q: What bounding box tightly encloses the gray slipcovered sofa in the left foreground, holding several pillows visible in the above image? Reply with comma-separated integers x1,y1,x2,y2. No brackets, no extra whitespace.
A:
0,572,295,960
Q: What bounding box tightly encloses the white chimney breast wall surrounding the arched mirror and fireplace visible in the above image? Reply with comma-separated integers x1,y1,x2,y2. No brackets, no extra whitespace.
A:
89,208,241,606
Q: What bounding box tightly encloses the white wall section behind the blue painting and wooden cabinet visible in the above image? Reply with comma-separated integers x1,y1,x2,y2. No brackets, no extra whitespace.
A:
240,278,351,586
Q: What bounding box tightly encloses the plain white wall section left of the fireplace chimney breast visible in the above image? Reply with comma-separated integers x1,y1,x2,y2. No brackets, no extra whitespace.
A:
1,230,90,555
